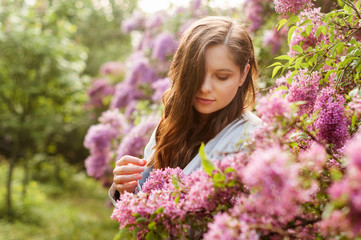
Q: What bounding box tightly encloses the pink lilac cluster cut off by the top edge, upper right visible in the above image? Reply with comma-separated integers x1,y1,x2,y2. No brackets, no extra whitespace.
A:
273,0,313,14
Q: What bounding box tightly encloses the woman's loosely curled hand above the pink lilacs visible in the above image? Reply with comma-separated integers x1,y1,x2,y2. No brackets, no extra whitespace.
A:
113,156,147,194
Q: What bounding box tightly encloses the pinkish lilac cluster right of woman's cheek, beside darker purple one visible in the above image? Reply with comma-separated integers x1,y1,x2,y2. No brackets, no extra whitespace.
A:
286,70,322,115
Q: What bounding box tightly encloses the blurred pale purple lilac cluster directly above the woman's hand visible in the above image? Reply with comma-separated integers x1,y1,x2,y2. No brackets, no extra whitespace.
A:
117,116,159,159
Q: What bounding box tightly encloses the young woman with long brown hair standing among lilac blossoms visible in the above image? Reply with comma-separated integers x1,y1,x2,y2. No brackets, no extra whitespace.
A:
109,17,261,203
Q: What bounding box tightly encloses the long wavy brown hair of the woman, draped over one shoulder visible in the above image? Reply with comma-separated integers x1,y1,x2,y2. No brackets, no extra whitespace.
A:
148,17,257,169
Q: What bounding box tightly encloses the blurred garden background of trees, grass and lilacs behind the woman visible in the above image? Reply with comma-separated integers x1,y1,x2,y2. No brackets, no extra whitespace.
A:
0,0,360,240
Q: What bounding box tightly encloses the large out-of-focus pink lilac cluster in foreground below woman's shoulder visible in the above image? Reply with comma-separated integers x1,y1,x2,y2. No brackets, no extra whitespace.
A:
242,146,309,223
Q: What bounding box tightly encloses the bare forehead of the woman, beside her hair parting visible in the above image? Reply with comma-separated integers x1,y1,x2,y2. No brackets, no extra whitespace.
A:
205,45,240,71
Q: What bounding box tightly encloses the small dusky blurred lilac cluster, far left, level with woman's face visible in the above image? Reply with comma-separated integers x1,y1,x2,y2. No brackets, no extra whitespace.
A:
87,79,114,107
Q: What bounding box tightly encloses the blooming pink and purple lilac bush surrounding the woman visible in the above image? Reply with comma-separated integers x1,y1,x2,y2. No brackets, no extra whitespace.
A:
84,0,361,239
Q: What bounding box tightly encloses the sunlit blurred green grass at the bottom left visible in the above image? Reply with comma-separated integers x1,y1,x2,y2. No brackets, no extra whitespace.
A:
0,164,119,240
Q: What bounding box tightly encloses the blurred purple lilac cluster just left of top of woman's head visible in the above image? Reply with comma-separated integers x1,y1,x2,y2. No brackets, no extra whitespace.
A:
152,32,178,61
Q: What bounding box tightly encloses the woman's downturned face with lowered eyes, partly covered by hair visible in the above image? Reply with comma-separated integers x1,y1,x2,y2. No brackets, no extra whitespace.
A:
193,45,249,116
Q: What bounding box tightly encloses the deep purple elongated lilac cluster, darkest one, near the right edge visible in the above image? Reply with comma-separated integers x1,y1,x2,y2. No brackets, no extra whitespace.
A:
311,88,349,148
